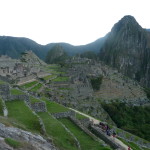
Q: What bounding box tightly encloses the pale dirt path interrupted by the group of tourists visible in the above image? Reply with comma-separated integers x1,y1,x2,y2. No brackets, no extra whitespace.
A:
69,108,128,150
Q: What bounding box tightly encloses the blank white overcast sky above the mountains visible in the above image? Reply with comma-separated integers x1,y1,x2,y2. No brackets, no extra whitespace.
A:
0,0,150,45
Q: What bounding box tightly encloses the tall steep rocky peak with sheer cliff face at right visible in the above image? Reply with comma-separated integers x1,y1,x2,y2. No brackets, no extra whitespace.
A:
100,16,150,87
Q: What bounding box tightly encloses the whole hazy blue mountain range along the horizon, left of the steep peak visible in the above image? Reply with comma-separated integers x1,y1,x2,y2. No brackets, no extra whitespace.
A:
0,36,105,60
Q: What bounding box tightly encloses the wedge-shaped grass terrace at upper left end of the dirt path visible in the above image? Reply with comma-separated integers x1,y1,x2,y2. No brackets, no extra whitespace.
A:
41,97,70,113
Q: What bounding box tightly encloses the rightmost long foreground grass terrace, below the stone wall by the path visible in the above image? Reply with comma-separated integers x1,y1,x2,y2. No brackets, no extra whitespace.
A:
59,119,109,150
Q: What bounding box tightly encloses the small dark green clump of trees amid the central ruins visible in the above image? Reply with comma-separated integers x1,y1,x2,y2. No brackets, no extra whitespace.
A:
90,75,103,90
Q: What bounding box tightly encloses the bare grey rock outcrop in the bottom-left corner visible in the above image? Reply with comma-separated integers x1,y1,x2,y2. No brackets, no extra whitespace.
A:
0,123,56,150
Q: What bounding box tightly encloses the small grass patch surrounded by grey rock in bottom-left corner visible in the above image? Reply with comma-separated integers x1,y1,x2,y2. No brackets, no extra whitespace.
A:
5,138,22,148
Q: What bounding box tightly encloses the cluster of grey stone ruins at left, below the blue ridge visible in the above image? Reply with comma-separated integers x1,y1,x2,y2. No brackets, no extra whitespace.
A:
0,51,49,84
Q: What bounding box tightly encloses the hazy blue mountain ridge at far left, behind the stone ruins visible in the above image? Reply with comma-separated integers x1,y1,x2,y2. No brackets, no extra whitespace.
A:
0,36,46,59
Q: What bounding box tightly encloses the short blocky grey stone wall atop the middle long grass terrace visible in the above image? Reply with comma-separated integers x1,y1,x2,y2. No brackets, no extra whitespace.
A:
31,102,47,112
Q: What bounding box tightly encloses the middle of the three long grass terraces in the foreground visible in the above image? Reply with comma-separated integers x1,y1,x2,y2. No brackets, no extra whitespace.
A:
38,112,77,150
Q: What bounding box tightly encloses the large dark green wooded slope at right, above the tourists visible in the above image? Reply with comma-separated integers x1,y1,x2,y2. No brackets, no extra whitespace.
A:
102,103,150,141
